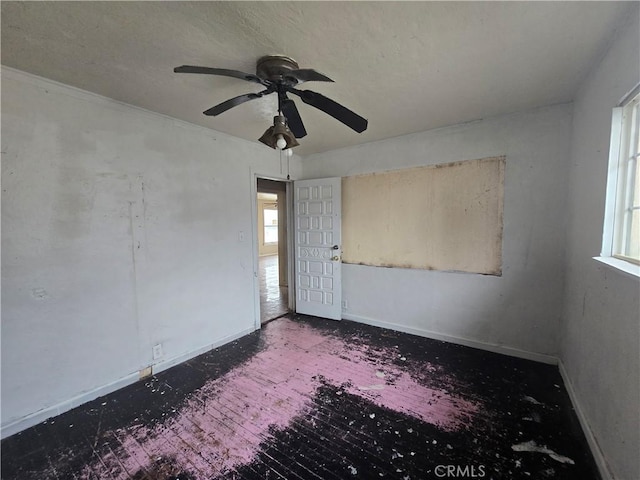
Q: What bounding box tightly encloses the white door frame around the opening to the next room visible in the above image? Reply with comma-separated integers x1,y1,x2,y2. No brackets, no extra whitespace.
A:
251,171,296,330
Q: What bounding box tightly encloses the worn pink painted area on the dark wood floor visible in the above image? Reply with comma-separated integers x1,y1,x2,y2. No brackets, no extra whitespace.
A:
83,319,479,480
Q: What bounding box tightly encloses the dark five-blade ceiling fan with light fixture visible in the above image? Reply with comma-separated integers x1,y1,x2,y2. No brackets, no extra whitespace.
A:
173,55,368,144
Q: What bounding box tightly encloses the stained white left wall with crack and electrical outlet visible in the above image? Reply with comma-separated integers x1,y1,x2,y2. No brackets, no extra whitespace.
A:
2,68,298,435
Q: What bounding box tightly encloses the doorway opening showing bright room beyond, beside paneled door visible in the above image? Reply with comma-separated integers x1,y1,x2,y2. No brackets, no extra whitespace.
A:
256,178,289,324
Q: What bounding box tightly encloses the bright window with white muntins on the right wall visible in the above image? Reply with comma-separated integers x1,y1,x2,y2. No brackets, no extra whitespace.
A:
600,86,640,275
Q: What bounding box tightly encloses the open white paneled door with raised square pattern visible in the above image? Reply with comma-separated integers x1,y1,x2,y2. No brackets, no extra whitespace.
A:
294,178,342,320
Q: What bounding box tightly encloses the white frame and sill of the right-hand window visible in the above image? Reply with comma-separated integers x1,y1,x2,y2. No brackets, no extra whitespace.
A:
594,84,640,277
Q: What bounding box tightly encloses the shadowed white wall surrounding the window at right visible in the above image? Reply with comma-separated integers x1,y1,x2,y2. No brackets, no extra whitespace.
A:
561,5,640,480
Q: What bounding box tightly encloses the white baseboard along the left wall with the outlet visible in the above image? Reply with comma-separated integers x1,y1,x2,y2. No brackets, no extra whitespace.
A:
0,327,255,439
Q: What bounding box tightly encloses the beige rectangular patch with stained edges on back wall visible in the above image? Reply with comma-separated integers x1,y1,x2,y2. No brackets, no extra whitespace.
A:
342,156,505,276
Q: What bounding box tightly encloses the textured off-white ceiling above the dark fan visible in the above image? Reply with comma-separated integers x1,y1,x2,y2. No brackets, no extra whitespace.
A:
1,1,631,155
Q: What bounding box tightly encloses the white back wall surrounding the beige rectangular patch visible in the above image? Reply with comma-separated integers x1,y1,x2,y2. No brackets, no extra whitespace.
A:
302,105,571,360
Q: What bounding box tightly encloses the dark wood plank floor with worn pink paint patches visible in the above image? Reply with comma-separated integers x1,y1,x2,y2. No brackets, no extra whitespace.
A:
1,315,598,480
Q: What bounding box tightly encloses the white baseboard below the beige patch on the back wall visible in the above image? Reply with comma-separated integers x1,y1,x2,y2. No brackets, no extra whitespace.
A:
342,312,558,365
